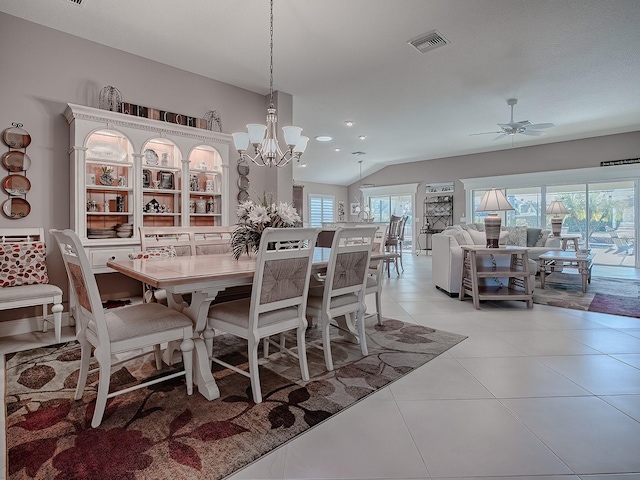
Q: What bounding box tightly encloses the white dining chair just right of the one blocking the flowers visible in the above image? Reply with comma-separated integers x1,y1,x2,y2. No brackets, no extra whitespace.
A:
307,227,377,370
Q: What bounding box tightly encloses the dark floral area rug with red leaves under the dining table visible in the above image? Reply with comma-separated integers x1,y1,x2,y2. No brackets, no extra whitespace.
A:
5,318,466,480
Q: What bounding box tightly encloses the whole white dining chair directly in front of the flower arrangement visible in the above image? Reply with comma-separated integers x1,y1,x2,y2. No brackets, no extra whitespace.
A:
203,228,320,403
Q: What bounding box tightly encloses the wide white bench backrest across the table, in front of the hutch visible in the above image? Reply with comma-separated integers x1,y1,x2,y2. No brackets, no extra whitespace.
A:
139,226,235,256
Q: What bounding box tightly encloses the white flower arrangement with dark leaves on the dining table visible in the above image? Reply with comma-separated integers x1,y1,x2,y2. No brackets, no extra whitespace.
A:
231,195,302,260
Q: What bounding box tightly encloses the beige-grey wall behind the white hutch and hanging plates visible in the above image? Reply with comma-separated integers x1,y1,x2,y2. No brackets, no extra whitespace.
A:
0,13,282,319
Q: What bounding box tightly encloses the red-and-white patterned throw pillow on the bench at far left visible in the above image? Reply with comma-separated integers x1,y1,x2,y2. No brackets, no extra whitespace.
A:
0,242,49,287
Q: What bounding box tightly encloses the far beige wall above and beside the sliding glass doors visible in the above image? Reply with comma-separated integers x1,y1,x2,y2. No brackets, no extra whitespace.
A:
349,131,640,231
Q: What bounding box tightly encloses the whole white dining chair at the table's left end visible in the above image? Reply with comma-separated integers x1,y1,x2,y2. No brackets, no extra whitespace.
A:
49,229,194,428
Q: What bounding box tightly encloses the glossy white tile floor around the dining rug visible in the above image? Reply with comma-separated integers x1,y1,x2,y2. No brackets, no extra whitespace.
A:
0,255,640,480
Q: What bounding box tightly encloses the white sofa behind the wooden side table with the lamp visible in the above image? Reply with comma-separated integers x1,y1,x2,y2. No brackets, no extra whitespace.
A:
431,224,562,296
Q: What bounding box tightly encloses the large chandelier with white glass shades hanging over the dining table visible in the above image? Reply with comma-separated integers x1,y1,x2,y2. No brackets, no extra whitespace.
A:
232,0,309,167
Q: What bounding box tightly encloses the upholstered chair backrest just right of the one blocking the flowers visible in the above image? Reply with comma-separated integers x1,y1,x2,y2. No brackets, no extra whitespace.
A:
322,226,377,309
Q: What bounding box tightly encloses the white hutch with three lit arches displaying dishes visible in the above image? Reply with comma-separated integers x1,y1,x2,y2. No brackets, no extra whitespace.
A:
64,104,231,273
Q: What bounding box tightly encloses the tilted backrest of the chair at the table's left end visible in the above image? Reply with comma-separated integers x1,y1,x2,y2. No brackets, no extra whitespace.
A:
49,229,109,348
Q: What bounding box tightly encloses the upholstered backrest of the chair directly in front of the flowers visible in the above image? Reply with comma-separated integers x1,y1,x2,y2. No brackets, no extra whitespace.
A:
249,228,320,331
